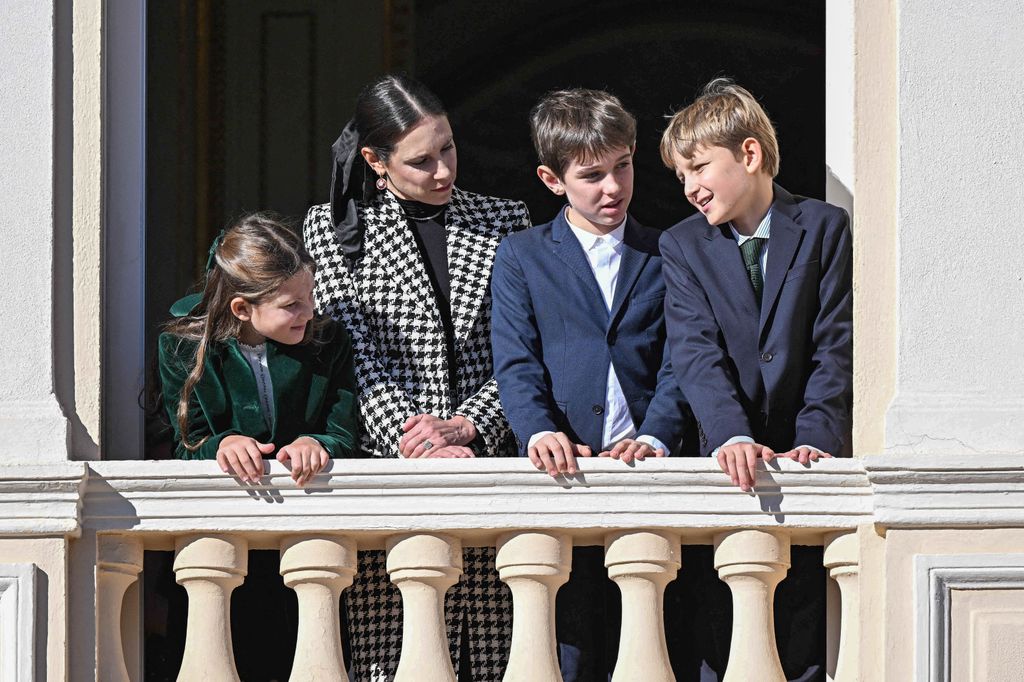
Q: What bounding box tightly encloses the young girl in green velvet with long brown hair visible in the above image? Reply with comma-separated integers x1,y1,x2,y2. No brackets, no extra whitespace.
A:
159,214,358,485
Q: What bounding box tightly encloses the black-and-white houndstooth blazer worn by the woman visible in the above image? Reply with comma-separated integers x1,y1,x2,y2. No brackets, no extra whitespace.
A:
303,188,529,457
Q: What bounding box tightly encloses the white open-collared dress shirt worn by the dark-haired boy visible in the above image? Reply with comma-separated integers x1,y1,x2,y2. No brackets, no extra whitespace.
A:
528,206,669,455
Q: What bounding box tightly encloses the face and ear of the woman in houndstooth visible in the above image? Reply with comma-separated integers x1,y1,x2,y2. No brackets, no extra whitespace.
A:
361,116,458,206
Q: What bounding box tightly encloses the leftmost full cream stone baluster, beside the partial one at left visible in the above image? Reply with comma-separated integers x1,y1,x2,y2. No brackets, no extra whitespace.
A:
174,536,249,682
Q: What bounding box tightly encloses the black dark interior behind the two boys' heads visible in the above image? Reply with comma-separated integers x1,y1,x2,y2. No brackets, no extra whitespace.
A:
415,0,825,227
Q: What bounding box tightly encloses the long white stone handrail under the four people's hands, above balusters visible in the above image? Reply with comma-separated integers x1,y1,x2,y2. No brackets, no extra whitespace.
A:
83,458,871,536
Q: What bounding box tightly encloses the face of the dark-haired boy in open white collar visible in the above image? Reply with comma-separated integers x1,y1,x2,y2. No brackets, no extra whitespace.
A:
537,146,633,235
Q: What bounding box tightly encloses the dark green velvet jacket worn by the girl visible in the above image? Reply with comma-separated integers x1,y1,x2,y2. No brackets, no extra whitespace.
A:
159,322,358,460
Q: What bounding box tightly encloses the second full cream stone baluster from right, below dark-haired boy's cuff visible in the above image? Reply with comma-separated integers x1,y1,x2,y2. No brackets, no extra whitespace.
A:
604,530,680,682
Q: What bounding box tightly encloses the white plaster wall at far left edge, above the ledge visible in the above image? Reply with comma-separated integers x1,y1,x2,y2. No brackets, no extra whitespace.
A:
0,0,68,462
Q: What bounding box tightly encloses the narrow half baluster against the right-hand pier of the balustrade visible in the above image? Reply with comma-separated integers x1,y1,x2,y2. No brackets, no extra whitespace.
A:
824,530,860,682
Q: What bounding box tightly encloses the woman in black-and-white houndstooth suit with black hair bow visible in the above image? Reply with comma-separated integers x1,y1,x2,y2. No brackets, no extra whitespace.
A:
304,71,529,680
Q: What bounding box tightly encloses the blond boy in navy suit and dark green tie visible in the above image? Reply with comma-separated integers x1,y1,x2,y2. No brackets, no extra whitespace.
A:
660,79,853,678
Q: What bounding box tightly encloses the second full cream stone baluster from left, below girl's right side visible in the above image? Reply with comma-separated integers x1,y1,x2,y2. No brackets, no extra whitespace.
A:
281,536,356,682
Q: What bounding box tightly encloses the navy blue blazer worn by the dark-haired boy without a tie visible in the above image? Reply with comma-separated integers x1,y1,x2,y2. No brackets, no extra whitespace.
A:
490,211,689,455
